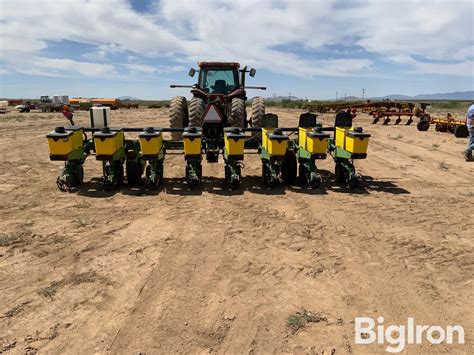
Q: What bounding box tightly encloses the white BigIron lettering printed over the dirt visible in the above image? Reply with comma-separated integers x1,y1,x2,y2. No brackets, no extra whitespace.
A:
355,317,464,353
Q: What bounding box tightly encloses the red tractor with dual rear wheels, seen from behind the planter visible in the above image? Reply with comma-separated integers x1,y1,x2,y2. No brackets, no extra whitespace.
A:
170,62,266,145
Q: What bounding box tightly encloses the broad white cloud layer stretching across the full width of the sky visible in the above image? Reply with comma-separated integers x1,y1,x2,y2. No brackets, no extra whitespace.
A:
0,0,474,77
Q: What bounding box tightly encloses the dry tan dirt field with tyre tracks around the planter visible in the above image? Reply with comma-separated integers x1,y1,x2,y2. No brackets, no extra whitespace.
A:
0,109,474,355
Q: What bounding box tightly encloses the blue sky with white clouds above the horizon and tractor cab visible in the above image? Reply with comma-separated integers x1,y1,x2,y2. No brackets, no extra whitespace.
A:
0,0,474,99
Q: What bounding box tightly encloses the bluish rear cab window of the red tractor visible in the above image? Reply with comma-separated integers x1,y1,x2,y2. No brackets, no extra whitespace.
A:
199,68,239,94
